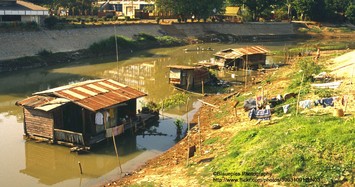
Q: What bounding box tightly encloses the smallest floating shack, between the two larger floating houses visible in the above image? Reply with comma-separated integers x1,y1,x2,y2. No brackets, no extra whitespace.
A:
167,65,210,90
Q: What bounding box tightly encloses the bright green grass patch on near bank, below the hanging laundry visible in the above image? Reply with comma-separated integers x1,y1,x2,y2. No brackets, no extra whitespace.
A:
209,116,355,186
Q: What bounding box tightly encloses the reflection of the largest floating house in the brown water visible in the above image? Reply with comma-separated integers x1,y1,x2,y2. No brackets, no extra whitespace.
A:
20,117,186,186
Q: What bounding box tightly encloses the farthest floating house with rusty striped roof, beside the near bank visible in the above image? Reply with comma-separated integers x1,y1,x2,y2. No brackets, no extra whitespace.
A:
214,46,269,69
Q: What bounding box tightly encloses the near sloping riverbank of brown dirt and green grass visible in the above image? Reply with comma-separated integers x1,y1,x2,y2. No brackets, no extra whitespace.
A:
110,47,355,186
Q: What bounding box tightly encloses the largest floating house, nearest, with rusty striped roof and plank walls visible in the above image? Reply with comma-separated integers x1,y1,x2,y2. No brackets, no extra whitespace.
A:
16,79,158,150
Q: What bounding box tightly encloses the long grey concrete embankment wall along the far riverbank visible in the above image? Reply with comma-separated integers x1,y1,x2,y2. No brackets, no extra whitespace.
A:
0,23,295,60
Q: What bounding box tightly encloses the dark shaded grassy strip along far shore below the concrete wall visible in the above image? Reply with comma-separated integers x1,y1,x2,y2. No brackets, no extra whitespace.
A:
0,33,185,72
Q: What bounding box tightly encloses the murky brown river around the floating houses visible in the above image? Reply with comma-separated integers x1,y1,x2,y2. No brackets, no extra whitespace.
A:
0,39,354,186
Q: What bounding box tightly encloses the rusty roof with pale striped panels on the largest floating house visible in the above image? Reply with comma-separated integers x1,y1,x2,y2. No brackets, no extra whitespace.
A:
18,79,146,111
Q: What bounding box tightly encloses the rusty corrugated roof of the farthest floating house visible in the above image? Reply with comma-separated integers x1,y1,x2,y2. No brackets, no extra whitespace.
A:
214,46,269,59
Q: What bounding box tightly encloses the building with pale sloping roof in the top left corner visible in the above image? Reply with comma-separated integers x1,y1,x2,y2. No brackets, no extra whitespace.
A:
0,0,49,24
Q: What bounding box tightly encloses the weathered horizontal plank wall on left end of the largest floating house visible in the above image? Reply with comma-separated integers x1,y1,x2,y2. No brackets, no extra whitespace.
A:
24,108,54,139
